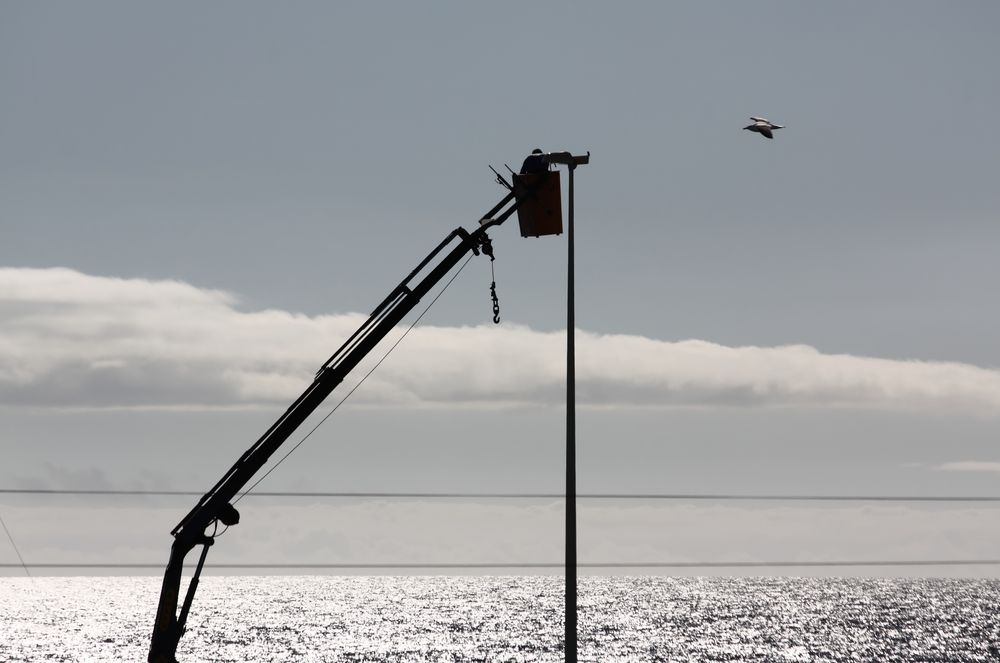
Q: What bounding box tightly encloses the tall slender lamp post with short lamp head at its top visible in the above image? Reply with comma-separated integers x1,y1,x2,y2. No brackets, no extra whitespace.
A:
542,152,590,663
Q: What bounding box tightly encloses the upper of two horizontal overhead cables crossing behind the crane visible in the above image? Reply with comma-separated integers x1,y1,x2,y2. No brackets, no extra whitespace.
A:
0,488,1000,502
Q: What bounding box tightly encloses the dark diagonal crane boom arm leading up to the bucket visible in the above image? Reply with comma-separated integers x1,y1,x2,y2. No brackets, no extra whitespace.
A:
153,193,517,663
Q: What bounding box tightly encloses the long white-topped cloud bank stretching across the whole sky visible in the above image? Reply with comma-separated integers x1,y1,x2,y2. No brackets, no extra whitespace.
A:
0,268,1000,415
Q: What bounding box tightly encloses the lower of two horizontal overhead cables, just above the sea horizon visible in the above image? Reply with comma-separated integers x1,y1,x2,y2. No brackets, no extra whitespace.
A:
0,559,1000,570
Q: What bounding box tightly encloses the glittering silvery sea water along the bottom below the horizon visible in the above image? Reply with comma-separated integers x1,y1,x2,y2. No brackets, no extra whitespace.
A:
0,576,1000,663
